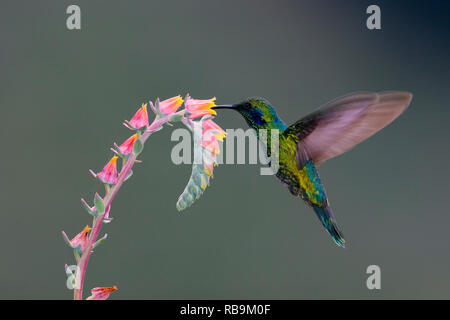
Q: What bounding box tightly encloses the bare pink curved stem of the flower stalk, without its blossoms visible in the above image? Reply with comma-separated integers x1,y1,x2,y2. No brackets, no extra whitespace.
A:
73,117,168,300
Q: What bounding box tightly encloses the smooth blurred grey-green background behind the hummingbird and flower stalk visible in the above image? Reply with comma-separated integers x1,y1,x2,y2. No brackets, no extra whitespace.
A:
0,0,450,299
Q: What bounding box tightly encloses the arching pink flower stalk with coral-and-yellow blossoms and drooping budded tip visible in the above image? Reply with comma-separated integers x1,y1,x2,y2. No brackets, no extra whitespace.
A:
62,95,225,300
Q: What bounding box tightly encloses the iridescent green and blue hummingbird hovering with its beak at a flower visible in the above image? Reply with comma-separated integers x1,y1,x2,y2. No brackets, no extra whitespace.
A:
213,91,412,248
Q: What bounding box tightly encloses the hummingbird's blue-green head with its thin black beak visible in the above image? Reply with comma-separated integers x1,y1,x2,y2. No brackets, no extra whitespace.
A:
213,98,279,130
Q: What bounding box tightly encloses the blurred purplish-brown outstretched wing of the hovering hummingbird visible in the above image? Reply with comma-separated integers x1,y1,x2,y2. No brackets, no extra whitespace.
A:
284,91,412,169
